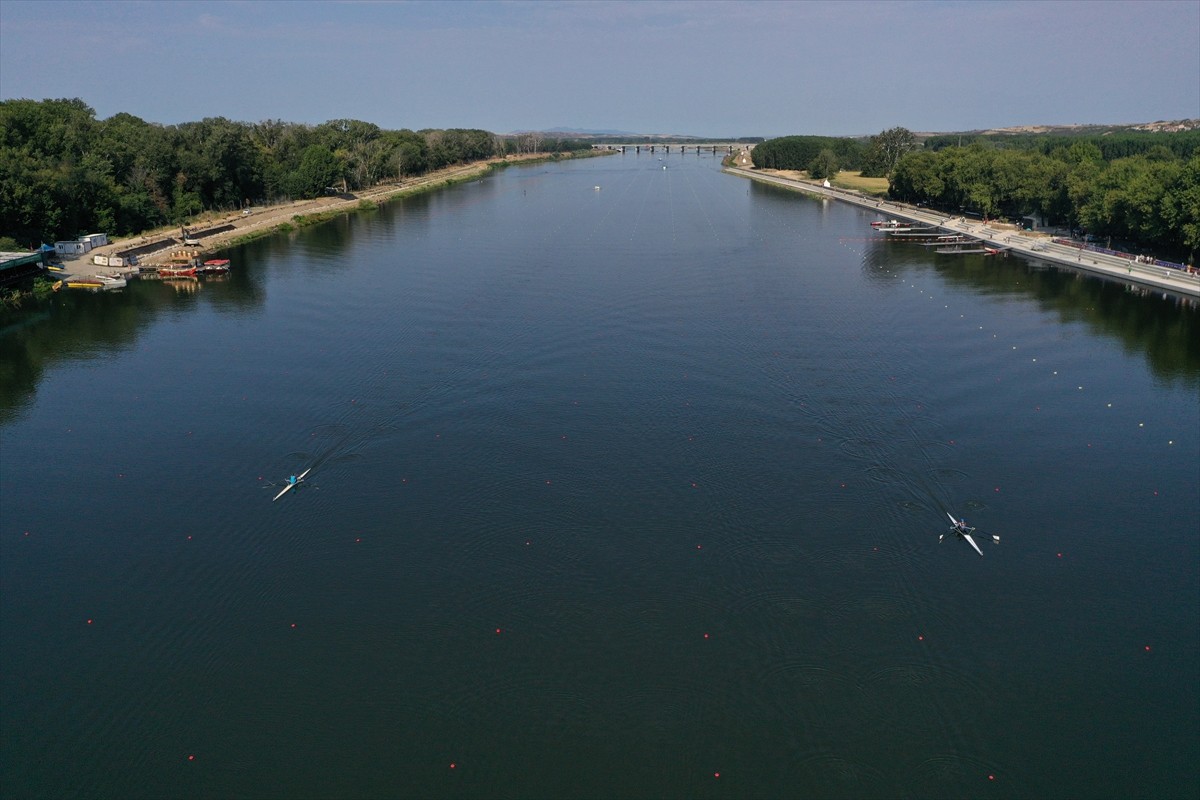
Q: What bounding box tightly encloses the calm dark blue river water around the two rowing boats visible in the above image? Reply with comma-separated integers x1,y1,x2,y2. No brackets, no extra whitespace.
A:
0,154,1200,799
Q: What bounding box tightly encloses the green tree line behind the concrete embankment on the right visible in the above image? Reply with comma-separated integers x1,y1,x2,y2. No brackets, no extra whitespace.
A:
751,127,1200,263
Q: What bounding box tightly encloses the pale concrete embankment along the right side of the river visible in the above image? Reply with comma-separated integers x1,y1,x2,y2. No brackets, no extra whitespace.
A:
725,167,1200,297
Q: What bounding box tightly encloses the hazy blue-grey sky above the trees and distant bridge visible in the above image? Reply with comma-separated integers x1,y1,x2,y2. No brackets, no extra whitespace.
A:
0,0,1200,138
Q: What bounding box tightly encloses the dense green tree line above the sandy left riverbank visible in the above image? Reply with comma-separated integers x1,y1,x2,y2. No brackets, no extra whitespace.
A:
0,98,589,245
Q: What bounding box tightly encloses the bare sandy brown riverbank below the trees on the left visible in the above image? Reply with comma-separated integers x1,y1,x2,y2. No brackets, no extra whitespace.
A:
72,150,607,276
